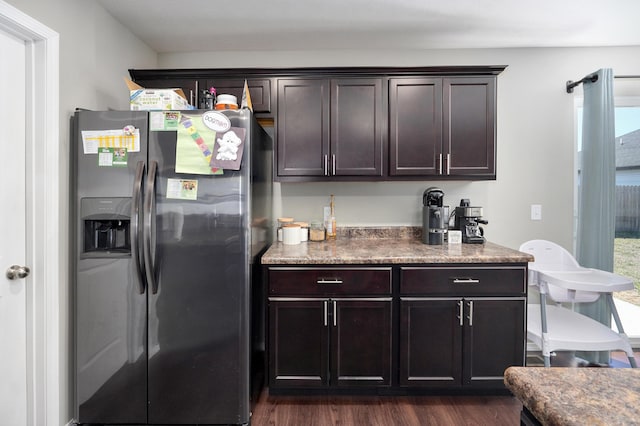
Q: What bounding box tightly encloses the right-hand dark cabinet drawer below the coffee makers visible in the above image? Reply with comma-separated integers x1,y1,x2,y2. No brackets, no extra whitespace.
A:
400,266,527,296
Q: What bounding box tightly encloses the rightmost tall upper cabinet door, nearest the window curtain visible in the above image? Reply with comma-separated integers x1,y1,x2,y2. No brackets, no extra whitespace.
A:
443,77,496,179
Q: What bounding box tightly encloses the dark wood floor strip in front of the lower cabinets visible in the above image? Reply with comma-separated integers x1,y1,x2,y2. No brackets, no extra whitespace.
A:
251,389,522,426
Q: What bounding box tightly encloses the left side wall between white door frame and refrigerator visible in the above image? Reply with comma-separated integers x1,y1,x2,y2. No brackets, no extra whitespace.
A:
5,0,157,425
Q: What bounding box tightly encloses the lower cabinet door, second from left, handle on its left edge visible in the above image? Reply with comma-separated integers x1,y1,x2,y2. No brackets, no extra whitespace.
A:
329,297,392,387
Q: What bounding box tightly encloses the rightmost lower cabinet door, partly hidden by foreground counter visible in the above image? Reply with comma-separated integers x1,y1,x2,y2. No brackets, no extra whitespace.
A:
464,298,526,388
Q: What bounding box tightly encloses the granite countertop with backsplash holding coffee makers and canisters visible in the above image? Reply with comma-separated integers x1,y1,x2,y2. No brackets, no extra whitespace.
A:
262,227,533,265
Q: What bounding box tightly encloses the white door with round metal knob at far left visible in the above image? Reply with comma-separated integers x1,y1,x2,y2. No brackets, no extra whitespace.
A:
0,25,31,425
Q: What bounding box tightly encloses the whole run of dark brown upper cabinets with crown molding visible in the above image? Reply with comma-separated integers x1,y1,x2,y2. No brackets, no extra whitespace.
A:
129,65,506,182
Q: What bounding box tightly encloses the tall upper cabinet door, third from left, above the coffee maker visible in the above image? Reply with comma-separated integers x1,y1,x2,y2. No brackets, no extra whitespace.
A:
389,78,443,176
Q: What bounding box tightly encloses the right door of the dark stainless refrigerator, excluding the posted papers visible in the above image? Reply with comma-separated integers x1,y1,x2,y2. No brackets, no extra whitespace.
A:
148,111,251,424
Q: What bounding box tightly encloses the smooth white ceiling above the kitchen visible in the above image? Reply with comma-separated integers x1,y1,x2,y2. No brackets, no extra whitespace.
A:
98,0,640,53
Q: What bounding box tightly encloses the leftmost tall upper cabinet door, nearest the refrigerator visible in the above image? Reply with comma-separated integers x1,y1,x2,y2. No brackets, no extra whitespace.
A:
276,79,329,176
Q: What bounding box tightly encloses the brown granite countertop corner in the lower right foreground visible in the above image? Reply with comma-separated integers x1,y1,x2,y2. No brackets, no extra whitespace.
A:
504,367,640,426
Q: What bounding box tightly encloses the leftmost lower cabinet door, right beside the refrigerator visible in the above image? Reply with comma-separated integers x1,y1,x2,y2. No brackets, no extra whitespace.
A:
269,298,329,388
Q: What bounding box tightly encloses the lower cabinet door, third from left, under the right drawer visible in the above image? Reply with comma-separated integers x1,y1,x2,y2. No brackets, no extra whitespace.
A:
399,297,464,388
